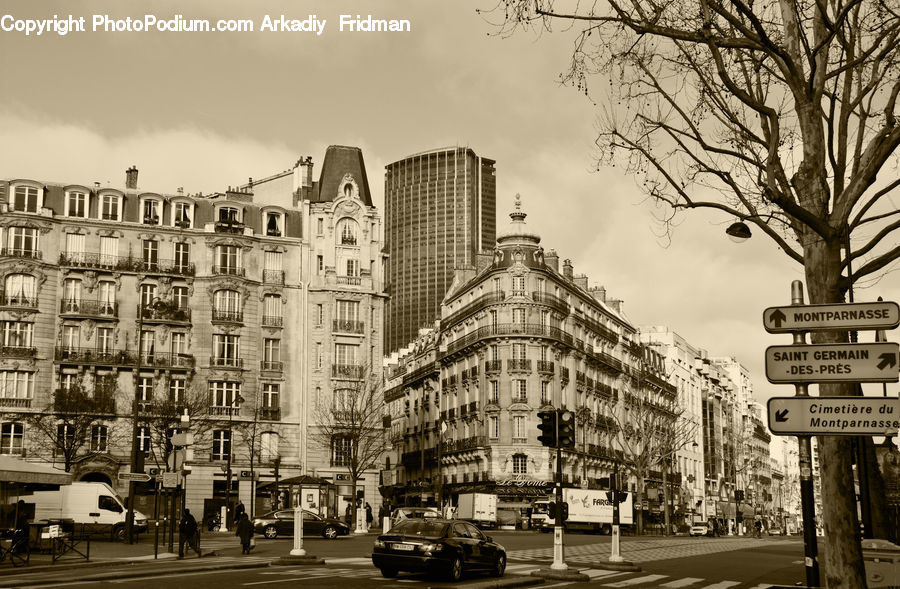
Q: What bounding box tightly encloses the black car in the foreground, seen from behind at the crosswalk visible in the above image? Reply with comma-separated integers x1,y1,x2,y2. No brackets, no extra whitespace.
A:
372,518,506,581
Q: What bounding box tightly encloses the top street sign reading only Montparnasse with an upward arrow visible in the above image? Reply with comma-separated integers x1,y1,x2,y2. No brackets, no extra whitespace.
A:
763,301,900,333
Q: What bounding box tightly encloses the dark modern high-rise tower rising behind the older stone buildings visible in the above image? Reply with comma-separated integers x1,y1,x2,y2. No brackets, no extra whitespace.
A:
384,147,497,353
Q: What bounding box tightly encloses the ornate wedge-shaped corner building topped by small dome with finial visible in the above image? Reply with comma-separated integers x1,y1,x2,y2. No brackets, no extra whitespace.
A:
383,198,675,519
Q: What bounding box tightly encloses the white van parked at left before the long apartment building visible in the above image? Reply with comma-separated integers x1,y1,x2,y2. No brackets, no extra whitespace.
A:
23,482,147,540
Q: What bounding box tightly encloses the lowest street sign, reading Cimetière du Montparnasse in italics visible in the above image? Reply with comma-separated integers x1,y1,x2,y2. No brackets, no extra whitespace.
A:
768,397,900,436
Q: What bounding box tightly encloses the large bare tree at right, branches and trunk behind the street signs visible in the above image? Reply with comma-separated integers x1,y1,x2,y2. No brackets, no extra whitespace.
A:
487,0,900,589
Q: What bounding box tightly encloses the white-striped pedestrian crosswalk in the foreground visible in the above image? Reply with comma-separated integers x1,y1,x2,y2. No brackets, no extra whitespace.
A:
244,557,776,589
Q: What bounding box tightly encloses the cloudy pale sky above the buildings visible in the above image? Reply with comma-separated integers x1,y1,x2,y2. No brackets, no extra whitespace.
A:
0,0,900,412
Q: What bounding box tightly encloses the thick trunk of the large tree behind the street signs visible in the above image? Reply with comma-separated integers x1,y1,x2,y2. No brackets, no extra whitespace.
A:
804,237,866,589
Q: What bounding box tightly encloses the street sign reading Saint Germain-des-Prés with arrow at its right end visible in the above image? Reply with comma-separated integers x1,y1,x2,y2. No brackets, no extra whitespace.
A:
766,342,900,383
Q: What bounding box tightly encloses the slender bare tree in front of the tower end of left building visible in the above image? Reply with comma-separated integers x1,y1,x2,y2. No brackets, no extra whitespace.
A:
309,367,390,525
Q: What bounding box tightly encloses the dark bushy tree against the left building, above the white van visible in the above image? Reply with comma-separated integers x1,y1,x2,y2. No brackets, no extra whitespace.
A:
22,378,119,472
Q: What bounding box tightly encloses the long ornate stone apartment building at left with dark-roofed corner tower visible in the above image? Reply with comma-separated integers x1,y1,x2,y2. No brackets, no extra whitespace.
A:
0,146,385,515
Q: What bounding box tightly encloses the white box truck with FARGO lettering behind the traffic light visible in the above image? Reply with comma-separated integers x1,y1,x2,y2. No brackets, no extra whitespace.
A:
531,489,634,534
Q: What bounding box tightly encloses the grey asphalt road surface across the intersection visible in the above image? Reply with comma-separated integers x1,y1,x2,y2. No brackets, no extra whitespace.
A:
8,532,804,589
